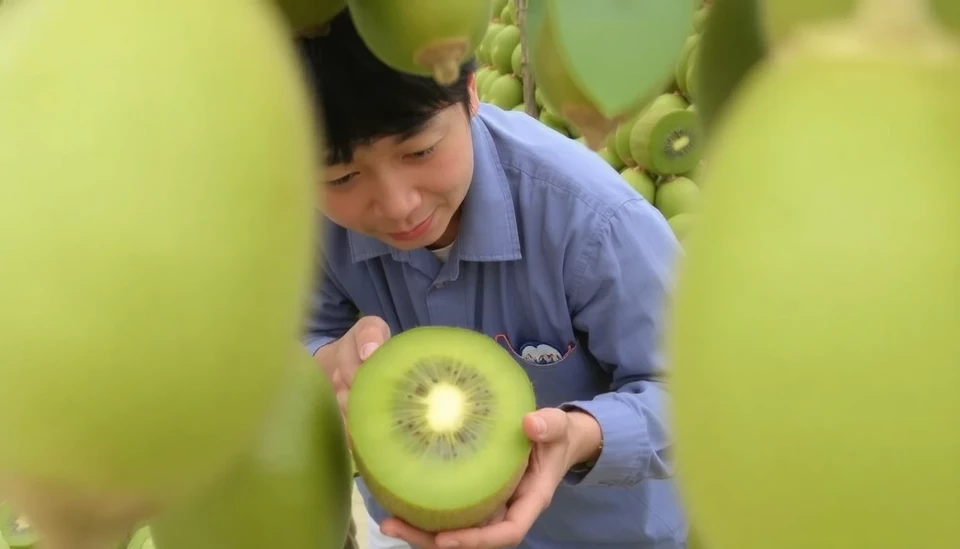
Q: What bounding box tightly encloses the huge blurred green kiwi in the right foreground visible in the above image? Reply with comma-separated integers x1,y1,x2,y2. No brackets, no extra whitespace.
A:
665,8,960,549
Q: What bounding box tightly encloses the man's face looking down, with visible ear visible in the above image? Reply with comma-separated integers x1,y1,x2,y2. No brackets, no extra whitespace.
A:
321,76,479,250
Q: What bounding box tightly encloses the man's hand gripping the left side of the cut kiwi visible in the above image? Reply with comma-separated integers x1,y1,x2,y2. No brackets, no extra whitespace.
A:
315,316,390,418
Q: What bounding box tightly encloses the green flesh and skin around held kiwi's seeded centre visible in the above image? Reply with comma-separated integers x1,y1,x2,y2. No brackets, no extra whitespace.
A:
347,326,536,532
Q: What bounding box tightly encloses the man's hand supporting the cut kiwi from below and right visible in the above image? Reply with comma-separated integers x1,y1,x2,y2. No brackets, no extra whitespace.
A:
380,408,601,549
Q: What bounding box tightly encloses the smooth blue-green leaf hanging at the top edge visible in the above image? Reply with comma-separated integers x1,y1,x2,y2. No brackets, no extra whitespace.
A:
548,0,694,116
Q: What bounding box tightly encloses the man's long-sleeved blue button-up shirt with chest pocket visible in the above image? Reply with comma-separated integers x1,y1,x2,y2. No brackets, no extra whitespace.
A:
304,105,687,549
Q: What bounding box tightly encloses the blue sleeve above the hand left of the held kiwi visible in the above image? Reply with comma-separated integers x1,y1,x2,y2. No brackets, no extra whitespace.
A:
301,254,360,355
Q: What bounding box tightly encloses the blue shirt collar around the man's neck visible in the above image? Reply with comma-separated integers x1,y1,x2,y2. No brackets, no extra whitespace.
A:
347,107,521,263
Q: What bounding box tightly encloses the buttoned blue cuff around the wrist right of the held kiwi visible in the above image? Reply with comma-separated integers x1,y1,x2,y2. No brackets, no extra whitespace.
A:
560,399,652,487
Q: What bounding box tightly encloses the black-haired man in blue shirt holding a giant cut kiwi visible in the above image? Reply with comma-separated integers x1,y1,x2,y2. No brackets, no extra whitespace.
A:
298,11,687,549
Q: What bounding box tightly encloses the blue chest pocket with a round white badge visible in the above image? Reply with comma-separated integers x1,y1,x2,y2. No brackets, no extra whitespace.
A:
494,334,610,408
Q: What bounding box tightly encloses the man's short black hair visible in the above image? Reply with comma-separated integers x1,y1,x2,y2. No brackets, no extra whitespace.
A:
296,10,476,164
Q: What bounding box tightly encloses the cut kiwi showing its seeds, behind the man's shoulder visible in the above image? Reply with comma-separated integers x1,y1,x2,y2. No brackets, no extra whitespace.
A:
630,94,701,175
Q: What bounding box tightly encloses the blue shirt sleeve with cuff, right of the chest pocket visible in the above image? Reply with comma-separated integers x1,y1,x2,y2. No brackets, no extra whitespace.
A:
561,200,680,486
